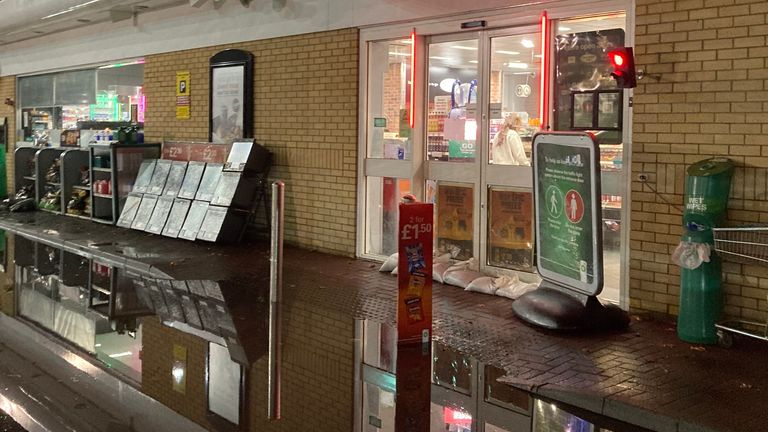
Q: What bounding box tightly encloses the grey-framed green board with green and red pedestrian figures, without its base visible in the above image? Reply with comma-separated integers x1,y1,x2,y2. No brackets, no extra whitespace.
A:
533,132,603,295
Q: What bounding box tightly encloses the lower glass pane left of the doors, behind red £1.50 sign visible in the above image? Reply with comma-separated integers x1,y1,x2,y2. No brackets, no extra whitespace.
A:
365,177,411,255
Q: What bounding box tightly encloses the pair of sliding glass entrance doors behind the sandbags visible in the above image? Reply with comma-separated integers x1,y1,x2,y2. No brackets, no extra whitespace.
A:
424,27,541,278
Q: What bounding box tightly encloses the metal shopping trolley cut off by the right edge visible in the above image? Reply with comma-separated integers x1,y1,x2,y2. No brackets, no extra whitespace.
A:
712,226,768,347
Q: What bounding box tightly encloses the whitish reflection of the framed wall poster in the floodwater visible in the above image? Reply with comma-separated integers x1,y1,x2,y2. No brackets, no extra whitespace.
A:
208,343,242,424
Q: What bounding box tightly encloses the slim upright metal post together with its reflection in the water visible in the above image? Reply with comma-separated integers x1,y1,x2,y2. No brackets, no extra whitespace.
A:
267,180,285,420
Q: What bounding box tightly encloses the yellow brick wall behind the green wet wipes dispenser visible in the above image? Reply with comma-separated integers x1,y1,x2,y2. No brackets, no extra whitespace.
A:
630,0,768,322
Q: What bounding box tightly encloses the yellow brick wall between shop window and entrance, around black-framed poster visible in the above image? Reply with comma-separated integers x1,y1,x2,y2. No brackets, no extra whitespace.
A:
144,29,358,256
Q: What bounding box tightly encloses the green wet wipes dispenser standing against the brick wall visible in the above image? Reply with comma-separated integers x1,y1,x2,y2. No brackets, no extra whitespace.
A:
677,158,733,344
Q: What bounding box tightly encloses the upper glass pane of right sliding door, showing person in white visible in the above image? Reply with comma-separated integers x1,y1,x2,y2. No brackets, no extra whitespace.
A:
488,34,541,165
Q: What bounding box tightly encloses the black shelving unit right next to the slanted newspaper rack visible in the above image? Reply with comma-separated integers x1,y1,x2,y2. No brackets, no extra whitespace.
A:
88,142,161,225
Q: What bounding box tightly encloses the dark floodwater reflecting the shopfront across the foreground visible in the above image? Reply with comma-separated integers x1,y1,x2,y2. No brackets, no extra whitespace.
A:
0,235,639,432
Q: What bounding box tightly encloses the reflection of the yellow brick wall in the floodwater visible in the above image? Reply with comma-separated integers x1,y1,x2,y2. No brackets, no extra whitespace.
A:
141,301,354,432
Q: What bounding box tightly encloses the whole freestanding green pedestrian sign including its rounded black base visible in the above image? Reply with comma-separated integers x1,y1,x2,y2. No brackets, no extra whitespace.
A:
512,132,629,330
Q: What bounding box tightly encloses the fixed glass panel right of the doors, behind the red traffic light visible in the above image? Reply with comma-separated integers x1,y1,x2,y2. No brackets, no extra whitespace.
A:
553,13,626,302
